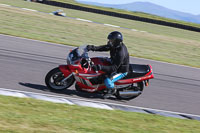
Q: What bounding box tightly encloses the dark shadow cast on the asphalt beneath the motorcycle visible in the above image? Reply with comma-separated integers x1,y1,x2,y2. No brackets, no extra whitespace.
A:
19,82,121,101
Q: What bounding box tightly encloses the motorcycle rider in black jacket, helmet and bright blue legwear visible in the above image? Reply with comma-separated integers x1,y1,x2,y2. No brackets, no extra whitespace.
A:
87,31,129,98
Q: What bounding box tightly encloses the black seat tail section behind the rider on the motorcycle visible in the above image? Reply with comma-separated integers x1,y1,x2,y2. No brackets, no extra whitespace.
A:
124,64,150,79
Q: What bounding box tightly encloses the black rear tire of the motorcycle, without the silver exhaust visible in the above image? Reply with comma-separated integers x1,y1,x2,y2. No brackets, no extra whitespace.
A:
115,82,144,100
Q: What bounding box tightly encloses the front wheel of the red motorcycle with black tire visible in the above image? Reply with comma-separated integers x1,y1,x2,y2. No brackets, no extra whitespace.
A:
45,67,75,92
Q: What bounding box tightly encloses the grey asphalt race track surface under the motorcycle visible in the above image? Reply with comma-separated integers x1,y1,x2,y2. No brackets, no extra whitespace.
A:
0,35,200,115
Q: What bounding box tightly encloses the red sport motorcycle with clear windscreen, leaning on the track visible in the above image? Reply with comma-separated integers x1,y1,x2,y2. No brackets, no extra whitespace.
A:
45,46,154,100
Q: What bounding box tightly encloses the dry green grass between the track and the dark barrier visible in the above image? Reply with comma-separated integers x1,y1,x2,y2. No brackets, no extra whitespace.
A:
0,0,200,67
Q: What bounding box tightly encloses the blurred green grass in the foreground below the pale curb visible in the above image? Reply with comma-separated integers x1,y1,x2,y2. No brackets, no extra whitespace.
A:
0,96,200,133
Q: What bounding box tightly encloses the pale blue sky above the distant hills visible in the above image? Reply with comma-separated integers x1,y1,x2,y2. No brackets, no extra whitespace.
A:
77,0,200,15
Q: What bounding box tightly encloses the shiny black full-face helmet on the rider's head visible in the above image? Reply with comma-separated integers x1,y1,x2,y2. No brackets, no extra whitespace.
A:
108,31,123,47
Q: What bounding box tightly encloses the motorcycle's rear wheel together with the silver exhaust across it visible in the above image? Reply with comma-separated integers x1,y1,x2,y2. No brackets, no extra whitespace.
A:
115,82,144,100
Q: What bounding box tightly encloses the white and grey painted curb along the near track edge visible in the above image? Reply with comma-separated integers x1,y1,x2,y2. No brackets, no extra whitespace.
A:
0,88,200,121
